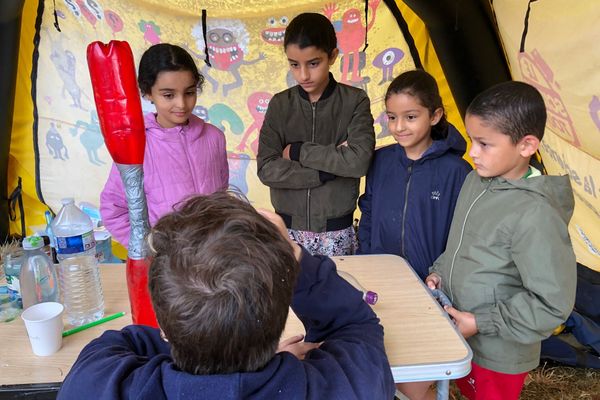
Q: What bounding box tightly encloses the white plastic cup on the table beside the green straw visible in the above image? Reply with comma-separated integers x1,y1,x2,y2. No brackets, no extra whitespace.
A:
21,301,65,356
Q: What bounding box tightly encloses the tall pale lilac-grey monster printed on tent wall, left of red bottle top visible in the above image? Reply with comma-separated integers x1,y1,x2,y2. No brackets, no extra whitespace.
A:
44,29,87,111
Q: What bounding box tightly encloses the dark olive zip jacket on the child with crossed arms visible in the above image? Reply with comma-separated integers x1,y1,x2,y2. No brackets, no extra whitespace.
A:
257,75,375,232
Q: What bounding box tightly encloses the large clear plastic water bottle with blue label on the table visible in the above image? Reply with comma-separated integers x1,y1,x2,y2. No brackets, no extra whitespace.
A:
51,198,104,326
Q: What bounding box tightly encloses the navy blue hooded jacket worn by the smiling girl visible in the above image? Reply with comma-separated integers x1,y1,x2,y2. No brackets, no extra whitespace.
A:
358,125,471,279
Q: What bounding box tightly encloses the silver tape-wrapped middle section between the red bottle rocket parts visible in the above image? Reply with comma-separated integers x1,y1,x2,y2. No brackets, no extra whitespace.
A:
116,163,150,260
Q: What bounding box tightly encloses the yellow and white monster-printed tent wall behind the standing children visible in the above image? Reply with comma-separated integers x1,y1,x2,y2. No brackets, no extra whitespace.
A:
9,0,464,255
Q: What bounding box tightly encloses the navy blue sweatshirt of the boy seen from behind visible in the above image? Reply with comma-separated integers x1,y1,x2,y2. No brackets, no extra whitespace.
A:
58,251,395,400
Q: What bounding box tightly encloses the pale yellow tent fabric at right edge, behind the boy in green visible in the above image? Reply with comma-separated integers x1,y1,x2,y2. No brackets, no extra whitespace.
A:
494,0,600,271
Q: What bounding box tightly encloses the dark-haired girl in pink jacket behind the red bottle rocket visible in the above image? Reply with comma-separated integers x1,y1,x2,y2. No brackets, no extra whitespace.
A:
100,43,229,246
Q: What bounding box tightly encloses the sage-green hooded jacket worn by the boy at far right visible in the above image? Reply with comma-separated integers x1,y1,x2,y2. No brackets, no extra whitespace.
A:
430,171,577,374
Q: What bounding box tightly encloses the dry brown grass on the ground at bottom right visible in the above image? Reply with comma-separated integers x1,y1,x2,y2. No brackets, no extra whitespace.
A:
450,362,600,400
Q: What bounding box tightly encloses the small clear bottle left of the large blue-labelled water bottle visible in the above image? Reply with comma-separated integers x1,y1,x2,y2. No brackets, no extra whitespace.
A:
19,236,59,309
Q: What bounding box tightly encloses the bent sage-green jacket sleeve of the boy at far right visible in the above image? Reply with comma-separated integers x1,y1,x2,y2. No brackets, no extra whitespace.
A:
474,207,577,343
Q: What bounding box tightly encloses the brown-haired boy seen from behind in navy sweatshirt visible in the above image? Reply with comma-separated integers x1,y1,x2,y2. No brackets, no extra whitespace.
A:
58,192,394,400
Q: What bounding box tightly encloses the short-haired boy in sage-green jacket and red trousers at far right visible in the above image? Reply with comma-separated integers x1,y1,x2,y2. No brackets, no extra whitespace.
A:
426,82,576,400
